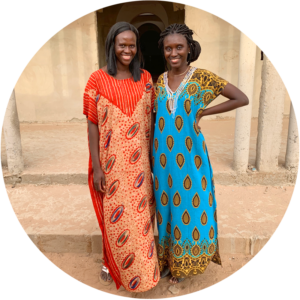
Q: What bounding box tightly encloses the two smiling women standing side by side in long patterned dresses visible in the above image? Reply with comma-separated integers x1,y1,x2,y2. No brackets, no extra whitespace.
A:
84,22,248,292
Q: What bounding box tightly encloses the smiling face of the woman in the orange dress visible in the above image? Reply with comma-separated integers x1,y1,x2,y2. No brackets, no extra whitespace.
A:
115,30,137,66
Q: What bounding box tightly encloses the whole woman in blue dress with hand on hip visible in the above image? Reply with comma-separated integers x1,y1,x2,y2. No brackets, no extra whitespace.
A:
152,24,249,283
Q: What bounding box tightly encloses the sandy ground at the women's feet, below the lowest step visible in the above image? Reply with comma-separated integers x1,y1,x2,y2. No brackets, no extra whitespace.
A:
41,253,255,300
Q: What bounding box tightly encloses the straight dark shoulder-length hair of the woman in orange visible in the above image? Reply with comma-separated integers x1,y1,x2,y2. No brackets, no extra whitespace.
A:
105,22,144,82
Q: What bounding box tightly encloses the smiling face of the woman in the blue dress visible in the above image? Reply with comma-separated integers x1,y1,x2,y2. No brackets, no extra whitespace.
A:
164,33,190,68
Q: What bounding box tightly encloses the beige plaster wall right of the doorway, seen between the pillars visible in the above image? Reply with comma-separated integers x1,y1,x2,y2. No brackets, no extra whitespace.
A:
185,4,291,119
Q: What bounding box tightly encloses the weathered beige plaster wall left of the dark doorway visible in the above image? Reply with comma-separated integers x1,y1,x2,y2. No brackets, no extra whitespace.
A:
14,11,98,122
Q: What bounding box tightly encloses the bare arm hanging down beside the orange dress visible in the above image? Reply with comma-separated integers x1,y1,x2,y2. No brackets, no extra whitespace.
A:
88,120,105,193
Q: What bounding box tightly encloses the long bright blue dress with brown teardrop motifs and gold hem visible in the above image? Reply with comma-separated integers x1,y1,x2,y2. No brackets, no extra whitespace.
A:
152,68,227,278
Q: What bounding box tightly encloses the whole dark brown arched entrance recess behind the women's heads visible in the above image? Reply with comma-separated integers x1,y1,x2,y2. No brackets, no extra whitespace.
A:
97,0,184,77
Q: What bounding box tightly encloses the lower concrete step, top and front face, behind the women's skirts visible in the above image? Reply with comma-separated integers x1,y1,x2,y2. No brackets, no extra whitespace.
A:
5,184,295,255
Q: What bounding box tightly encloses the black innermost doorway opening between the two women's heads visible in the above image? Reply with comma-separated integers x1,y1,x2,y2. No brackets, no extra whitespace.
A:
138,23,165,83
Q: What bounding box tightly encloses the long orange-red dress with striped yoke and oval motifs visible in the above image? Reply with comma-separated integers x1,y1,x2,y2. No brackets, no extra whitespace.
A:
83,69,160,292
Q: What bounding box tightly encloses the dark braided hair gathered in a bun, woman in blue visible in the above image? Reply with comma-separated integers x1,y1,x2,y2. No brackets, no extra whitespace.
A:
158,23,201,66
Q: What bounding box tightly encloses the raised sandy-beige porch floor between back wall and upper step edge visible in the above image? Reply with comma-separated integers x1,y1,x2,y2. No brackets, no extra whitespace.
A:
0,118,289,175
